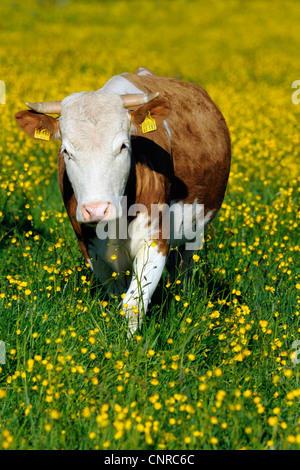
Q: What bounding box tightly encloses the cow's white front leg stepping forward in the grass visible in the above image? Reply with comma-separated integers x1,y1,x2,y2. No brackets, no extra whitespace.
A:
123,240,167,334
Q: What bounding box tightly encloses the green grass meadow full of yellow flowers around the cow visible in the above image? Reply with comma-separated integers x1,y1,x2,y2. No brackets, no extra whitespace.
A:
0,0,300,450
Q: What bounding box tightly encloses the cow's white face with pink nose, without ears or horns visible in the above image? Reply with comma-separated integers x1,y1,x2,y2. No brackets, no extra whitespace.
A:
59,92,131,223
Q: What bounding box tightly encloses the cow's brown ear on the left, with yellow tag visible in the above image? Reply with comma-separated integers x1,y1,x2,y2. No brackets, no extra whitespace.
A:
15,111,61,140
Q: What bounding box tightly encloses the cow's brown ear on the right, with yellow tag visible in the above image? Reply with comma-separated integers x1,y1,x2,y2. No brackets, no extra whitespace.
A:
130,98,171,132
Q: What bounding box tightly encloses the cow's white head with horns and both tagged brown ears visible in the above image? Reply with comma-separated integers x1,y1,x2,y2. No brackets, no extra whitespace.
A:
16,91,170,223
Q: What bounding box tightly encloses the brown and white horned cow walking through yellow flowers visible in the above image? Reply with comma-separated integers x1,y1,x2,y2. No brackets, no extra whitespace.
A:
15,67,231,334
